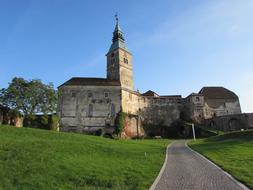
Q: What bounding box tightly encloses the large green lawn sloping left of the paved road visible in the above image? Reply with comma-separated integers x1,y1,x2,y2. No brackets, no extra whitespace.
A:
0,125,169,190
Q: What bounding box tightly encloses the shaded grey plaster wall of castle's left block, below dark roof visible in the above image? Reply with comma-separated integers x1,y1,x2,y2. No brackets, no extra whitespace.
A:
58,86,121,132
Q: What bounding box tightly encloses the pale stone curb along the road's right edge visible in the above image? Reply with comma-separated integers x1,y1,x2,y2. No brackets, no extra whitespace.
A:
185,141,250,190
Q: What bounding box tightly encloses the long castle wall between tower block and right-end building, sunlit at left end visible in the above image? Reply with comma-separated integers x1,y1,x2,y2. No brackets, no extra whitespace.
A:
122,90,181,126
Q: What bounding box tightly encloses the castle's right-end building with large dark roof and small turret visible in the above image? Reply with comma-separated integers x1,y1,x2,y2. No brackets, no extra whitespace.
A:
185,87,241,122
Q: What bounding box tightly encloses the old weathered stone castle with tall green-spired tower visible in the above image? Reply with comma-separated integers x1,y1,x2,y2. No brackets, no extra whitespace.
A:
57,19,241,137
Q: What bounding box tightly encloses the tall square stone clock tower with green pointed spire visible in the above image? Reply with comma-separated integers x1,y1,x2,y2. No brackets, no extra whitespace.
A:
106,17,134,90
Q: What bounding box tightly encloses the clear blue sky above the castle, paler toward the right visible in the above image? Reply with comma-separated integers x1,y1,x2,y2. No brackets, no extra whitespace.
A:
0,0,253,112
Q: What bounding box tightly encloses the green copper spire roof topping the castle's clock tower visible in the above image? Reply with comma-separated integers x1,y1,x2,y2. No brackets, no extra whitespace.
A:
108,15,129,53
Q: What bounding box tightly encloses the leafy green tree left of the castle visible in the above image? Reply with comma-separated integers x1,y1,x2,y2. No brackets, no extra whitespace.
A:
0,77,57,117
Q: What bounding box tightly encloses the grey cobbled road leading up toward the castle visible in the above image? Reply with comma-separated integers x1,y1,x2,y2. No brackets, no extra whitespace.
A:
155,141,247,190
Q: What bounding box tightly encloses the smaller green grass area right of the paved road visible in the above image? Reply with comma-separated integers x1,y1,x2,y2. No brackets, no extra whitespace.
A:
189,130,253,189
